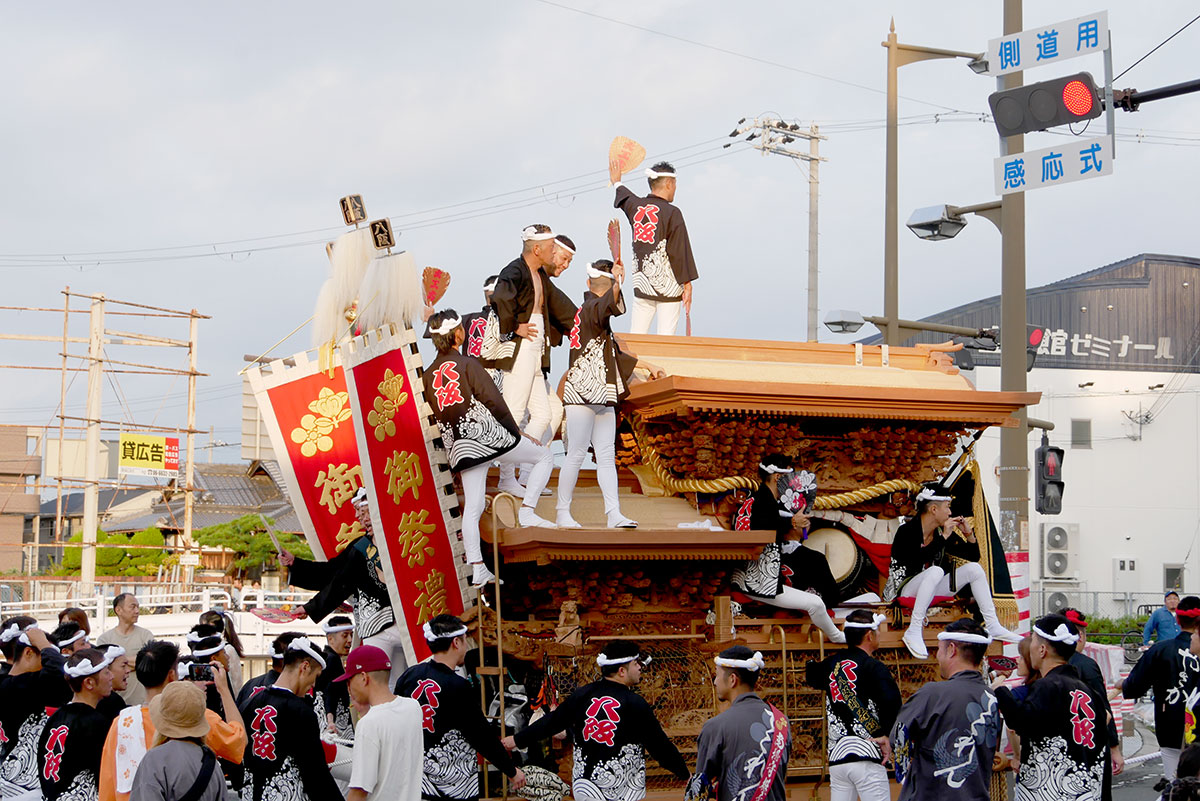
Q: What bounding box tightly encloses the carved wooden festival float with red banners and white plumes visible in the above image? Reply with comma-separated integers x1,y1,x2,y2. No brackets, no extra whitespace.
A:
241,197,1038,793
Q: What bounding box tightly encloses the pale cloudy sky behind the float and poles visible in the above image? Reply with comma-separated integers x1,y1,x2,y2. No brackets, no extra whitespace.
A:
0,0,1200,472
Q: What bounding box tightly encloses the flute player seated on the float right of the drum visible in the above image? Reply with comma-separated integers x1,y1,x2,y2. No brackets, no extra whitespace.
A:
883,483,1021,660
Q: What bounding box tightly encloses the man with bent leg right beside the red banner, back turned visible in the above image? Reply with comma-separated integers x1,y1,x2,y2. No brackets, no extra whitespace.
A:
421,309,554,586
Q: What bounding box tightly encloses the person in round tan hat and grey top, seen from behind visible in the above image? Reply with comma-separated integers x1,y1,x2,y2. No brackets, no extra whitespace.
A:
130,681,227,801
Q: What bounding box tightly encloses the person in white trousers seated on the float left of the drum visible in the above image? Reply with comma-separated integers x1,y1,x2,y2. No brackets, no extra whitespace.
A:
730,453,846,643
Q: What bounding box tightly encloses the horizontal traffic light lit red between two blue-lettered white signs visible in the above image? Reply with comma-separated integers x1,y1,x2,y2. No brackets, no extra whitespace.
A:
988,72,1104,137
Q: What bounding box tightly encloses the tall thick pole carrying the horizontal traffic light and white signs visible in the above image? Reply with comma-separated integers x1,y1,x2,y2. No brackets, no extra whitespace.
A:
998,0,1030,633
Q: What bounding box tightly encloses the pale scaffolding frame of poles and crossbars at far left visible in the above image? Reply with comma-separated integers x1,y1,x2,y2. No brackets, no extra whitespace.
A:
0,287,210,587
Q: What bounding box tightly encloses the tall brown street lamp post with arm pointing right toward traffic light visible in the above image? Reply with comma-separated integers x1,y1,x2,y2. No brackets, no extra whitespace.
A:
882,18,984,345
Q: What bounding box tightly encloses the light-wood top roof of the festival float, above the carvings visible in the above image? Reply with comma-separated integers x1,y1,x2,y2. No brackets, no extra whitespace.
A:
618,335,1040,427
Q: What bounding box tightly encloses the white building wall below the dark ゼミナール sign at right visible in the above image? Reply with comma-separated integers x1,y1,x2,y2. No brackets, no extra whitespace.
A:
967,367,1200,592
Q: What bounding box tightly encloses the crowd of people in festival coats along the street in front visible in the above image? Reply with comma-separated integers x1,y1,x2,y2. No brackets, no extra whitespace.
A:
7,582,1200,801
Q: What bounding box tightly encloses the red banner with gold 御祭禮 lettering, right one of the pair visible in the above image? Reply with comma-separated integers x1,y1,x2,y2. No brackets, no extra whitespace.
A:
342,331,463,663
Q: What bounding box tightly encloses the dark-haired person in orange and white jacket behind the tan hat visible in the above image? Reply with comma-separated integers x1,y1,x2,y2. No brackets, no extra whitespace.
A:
100,640,246,801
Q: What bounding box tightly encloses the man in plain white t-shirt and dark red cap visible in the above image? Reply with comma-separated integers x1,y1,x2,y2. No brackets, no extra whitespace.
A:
334,645,425,801
